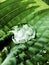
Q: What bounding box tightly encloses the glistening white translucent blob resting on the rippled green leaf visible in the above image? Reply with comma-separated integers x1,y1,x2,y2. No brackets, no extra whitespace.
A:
10,24,35,44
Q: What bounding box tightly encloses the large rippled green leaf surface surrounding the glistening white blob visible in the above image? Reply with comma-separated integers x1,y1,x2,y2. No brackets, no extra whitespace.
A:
0,0,49,65
